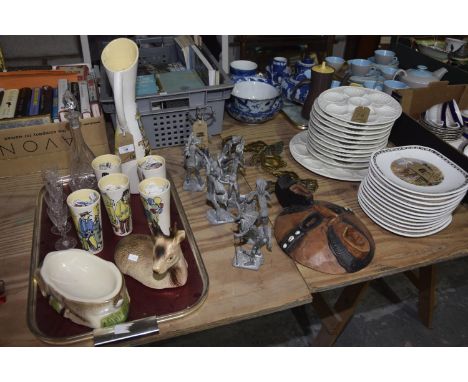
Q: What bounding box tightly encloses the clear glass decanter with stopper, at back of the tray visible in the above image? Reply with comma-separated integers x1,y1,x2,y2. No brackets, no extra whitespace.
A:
63,91,97,191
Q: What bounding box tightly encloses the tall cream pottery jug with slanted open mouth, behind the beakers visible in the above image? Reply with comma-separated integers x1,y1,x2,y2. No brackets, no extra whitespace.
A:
101,38,149,194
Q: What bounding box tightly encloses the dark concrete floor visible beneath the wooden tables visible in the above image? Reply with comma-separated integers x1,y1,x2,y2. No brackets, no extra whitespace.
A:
155,258,468,346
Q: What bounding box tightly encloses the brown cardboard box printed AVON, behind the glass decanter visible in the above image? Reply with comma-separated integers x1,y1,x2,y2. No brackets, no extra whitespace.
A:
0,117,110,176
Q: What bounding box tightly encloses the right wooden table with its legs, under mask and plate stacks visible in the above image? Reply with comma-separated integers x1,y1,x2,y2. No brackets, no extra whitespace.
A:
238,112,468,345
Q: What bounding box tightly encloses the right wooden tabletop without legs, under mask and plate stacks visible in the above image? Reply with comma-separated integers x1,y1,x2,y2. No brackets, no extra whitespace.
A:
239,115,468,293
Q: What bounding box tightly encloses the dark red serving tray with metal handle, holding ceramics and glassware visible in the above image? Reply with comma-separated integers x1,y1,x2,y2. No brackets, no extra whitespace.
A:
27,176,208,345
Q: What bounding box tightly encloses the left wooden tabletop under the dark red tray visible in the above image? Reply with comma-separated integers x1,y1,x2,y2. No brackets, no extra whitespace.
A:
0,113,311,346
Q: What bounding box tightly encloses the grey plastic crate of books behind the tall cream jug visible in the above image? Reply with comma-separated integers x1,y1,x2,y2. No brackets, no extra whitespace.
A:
100,36,234,149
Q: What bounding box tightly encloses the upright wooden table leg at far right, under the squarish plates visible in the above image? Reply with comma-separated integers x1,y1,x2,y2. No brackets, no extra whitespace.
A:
419,265,436,328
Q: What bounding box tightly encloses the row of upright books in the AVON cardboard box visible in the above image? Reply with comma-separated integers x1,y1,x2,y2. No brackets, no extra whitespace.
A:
0,77,101,123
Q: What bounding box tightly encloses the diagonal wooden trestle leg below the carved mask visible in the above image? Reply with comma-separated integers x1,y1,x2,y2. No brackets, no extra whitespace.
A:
311,282,369,346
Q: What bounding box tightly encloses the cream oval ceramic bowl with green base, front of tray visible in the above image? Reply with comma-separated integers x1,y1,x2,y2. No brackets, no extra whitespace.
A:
34,249,130,328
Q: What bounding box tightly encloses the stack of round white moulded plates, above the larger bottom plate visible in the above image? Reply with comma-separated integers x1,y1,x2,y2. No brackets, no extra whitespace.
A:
307,86,401,170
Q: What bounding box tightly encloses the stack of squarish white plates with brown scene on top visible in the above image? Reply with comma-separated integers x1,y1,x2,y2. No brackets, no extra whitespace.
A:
358,146,468,237
